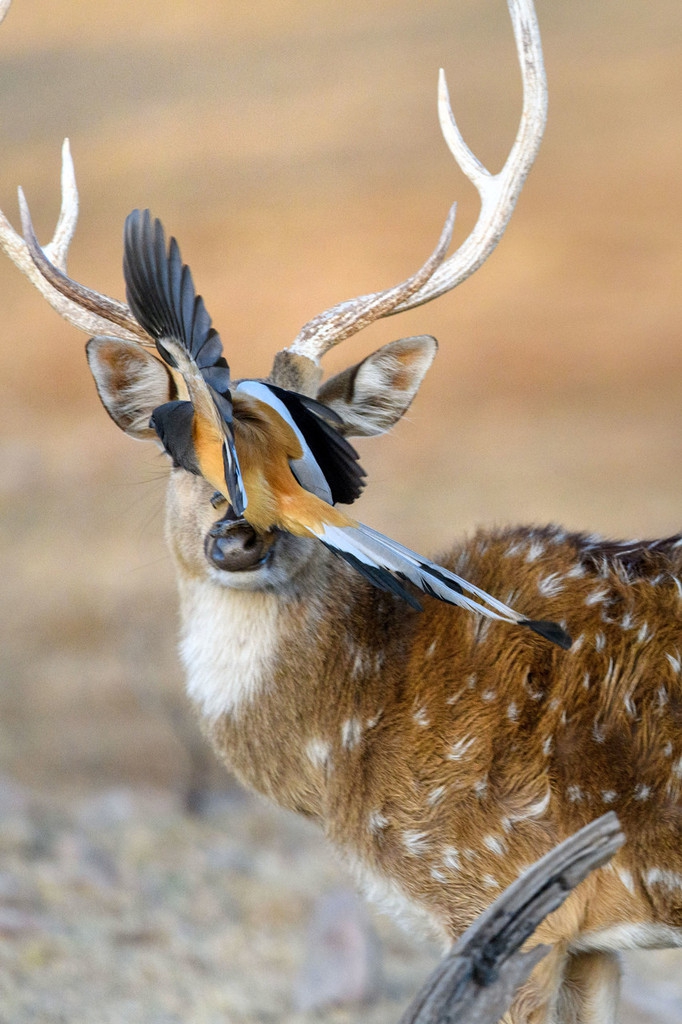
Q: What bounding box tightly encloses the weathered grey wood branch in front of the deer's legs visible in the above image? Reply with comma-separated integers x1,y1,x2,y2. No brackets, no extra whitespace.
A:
399,812,625,1024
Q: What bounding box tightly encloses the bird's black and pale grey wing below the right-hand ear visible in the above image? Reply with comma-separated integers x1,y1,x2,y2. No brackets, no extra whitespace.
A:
236,380,366,505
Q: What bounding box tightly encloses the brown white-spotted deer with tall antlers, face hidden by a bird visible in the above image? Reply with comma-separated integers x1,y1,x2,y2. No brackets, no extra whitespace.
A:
0,0,682,1024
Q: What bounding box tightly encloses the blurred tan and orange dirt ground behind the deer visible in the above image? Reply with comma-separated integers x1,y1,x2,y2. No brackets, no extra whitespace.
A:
0,0,682,1024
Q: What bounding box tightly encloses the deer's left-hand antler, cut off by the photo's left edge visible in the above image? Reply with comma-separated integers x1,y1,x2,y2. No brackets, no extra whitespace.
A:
0,138,152,345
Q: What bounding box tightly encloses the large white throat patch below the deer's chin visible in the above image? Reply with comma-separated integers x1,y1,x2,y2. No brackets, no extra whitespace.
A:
180,579,286,722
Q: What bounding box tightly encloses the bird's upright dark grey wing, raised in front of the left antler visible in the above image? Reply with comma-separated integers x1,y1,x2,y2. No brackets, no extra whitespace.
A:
123,210,247,516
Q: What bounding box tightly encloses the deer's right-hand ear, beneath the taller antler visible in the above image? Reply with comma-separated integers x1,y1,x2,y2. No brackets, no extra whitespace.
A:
317,335,438,437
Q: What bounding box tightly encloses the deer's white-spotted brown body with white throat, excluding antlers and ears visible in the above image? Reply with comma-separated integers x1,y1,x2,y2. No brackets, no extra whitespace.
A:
168,473,682,1021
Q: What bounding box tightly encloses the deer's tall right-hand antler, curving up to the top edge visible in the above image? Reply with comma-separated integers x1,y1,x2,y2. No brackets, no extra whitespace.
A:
287,0,547,362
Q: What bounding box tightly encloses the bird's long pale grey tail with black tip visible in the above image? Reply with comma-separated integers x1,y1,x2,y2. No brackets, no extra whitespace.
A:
317,523,571,650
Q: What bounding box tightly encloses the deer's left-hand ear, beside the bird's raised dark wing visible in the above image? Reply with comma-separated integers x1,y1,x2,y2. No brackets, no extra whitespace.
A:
85,336,177,440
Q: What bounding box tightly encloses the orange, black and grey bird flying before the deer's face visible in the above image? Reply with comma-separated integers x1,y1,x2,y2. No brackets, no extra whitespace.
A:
123,210,571,649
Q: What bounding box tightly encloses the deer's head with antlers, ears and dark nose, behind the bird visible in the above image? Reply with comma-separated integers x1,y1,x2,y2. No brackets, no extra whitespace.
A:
0,0,546,589
